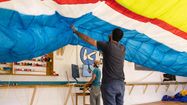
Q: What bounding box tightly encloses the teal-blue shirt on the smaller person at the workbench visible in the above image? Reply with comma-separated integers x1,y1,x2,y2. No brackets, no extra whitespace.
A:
92,68,101,86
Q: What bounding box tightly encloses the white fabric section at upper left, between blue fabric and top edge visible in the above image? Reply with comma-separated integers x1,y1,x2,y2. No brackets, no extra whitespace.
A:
0,0,100,17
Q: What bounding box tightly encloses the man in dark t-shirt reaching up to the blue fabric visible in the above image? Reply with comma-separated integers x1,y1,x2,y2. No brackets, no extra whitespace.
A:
71,26,125,105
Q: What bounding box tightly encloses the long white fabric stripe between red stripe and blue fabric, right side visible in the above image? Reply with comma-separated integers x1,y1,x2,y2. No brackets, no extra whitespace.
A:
93,3,187,51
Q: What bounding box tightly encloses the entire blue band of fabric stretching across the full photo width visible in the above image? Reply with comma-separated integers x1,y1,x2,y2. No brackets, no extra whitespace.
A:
0,9,187,76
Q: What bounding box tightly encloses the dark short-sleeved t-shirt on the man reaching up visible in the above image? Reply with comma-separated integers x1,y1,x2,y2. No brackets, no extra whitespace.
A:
97,41,125,83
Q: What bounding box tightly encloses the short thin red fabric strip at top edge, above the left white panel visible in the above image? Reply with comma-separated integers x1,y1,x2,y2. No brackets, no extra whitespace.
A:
54,0,99,4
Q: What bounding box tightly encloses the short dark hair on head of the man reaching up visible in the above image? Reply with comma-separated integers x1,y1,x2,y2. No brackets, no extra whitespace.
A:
112,28,123,42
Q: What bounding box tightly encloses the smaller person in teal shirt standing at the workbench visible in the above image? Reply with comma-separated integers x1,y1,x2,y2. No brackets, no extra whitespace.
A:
85,60,101,105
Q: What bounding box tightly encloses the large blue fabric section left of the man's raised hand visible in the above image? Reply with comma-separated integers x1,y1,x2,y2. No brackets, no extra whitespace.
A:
0,9,76,62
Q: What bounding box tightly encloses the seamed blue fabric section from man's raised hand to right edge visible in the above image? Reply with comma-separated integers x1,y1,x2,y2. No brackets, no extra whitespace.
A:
75,14,187,76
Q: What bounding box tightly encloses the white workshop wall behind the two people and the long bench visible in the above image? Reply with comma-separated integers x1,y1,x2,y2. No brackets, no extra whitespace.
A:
0,46,187,105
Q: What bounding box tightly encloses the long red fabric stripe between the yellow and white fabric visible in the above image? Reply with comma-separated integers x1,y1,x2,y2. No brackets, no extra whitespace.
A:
106,0,187,40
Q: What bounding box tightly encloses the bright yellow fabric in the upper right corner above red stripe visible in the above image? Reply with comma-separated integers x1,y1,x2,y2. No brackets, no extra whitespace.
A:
116,0,187,32
